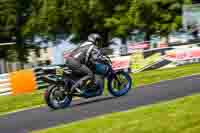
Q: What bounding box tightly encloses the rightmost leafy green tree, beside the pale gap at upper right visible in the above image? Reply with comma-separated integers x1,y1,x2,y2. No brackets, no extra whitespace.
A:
127,0,191,40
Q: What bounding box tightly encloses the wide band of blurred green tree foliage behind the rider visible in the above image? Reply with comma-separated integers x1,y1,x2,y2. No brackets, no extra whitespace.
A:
9,0,190,50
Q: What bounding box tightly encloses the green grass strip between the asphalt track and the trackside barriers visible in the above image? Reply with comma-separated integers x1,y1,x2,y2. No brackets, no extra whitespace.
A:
0,64,200,114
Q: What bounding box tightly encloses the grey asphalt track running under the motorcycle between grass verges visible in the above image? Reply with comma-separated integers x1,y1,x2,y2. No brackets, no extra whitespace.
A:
0,75,200,133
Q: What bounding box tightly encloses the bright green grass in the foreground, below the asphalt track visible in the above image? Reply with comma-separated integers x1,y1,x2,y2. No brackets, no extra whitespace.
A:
34,95,200,133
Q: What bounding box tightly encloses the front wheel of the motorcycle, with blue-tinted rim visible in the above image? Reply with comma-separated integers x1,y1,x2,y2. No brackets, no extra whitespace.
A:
108,71,132,97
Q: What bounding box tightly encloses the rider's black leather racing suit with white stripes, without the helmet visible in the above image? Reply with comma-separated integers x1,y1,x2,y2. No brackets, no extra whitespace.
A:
66,42,100,90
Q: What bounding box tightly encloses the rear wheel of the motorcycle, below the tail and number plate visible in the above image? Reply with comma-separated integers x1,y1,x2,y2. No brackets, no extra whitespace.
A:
44,85,72,110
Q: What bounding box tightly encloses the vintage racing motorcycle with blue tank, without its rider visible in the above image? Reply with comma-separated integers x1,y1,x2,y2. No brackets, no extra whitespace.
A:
43,52,132,109
